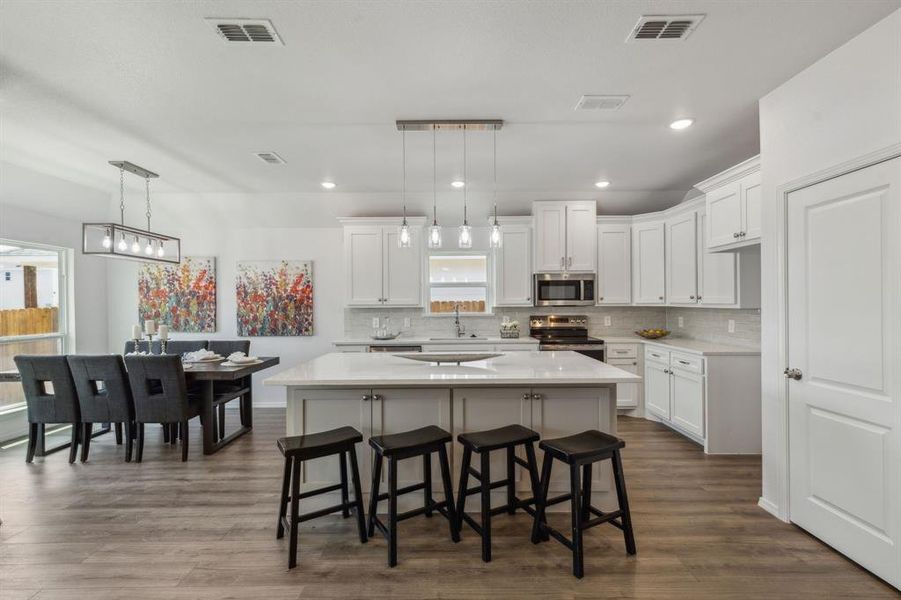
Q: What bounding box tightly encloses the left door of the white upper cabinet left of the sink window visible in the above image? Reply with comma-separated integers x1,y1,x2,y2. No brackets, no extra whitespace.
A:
344,226,384,306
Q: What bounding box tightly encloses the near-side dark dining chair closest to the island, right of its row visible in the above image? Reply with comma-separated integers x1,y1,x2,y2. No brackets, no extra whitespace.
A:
125,354,200,462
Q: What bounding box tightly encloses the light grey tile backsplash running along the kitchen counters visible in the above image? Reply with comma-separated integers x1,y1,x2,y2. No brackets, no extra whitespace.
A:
344,306,760,347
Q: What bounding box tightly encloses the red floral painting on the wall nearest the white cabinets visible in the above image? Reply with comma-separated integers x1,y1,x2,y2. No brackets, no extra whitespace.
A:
235,260,313,336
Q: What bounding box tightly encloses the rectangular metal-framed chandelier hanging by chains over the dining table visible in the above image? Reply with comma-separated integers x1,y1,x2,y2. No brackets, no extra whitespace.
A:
81,160,181,264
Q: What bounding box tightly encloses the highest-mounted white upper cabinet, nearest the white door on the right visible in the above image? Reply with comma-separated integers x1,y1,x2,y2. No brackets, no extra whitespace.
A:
695,156,761,250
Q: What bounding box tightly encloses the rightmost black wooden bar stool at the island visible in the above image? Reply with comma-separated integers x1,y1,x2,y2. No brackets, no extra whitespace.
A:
532,430,636,578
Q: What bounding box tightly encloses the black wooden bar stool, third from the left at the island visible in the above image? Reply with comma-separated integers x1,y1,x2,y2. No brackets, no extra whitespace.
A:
457,425,541,562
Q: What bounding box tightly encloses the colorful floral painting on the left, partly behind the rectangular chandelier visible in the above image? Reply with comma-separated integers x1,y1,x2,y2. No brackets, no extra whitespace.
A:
138,256,216,333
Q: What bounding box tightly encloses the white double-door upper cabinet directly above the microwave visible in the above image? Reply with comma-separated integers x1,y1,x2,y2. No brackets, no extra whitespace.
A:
532,200,597,272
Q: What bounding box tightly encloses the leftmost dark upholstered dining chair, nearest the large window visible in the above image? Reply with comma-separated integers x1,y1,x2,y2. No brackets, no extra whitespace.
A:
13,355,81,463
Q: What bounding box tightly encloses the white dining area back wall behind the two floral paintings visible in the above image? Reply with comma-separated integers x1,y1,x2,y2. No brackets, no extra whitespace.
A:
107,225,344,406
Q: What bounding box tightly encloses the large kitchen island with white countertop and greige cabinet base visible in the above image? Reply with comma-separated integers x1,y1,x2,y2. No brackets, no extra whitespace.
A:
264,351,640,510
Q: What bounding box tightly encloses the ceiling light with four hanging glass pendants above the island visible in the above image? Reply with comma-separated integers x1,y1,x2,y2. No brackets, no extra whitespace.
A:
395,119,504,249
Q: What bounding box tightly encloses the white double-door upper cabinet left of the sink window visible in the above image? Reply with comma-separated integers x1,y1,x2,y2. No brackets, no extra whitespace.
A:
342,218,425,306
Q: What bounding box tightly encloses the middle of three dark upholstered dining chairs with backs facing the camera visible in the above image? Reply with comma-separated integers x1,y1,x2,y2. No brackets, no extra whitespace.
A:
68,354,135,462
